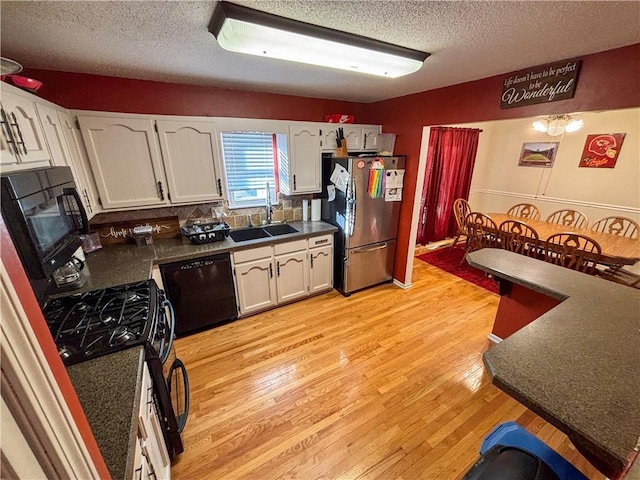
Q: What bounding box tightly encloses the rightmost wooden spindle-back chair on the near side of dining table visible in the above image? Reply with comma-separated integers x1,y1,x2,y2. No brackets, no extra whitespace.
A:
544,232,602,275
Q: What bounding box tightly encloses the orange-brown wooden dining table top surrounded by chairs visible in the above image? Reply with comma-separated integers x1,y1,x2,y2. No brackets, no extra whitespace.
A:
487,213,640,265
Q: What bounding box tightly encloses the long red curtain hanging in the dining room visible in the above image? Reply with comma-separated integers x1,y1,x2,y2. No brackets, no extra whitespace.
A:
417,127,482,245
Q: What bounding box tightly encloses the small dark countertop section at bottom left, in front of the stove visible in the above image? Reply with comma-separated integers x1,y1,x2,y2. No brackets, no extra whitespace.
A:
67,347,144,479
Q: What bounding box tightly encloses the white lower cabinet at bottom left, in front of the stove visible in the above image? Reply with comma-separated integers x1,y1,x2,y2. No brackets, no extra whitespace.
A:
132,363,171,480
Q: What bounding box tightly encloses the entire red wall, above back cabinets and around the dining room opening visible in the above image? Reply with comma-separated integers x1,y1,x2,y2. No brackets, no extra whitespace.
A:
25,44,640,281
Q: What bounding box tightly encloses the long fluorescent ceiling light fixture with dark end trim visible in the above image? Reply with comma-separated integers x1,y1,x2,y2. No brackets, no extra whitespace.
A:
209,2,430,78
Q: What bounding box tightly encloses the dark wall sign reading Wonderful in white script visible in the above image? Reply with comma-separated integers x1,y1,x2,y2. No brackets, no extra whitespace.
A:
500,60,581,109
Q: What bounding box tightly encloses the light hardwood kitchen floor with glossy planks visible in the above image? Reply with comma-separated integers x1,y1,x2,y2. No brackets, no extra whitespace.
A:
172,259,604,480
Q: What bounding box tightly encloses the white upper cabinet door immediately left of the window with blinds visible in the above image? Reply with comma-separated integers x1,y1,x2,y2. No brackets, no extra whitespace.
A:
156,120,222,203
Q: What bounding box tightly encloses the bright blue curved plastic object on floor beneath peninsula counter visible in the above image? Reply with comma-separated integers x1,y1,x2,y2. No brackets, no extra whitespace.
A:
480,422,589,480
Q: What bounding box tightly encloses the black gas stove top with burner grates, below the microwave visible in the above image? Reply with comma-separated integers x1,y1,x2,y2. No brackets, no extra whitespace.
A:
43,280,171,365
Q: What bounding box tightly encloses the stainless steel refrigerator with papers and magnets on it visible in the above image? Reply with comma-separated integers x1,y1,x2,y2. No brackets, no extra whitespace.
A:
322,156,405,296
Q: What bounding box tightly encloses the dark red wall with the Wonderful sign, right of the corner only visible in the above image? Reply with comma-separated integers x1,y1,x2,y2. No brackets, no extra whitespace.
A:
368,44,640,281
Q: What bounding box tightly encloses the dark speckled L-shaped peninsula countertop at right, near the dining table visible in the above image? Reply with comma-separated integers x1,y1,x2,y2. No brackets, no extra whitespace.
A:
467,249,640,475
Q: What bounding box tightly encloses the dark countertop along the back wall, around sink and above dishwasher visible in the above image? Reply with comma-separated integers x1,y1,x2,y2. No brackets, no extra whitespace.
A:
58,222,338,298
